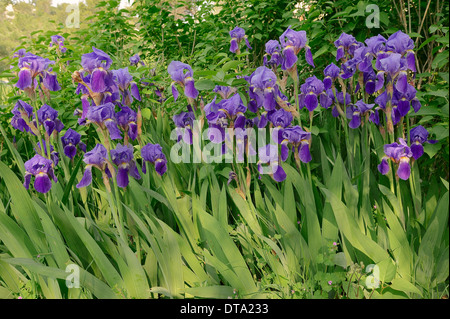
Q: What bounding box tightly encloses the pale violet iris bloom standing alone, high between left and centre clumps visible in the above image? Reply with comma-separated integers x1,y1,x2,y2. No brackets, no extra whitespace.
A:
167,61,198,101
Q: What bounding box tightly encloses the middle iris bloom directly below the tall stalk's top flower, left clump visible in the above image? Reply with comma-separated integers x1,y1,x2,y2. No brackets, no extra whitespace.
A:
86,103,122,140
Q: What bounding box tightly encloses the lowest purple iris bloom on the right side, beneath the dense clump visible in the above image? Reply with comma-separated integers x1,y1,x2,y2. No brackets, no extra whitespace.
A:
378,138,413,180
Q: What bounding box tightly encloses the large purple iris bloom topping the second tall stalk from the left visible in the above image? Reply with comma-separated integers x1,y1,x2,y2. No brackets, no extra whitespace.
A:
81,47,112,93
